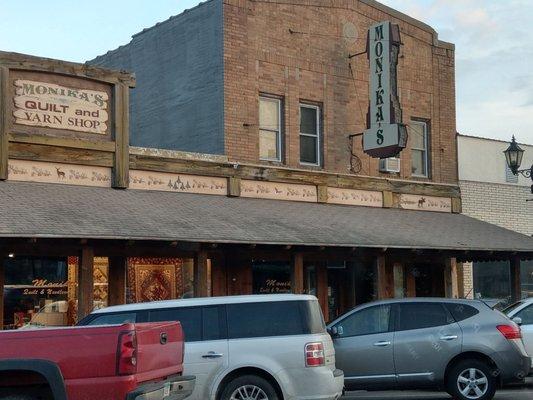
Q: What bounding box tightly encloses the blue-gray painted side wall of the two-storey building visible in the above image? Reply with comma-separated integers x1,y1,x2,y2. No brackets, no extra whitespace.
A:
89,0,224,154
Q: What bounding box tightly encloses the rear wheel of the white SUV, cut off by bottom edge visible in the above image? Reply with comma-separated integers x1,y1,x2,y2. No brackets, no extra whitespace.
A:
220,375,279,400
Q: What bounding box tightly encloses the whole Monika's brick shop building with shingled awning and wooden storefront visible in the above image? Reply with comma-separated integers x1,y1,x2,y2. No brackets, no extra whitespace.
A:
0,0,533,327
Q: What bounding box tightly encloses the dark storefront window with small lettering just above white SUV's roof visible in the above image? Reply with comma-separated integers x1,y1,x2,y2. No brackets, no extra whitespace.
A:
252,261,292,294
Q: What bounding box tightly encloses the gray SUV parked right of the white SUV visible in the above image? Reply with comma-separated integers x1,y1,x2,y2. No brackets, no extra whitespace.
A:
328,298,531,400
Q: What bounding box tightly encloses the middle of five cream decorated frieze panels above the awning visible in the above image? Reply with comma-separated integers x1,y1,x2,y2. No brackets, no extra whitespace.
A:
241,179,318,203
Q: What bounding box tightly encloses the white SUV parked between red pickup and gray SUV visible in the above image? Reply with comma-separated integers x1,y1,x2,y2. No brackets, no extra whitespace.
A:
79,294,344,400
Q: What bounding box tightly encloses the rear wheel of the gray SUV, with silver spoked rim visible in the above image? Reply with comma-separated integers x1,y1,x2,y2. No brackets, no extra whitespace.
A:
446,360,497,400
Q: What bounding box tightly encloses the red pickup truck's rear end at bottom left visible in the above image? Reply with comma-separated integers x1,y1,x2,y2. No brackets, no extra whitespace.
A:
0,322,195,400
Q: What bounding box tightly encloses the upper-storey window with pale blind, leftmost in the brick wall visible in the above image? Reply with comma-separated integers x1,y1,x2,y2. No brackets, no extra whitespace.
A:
259,96,282,162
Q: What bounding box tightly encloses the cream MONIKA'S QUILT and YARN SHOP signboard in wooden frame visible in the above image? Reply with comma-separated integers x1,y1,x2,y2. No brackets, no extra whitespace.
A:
13,79,109,135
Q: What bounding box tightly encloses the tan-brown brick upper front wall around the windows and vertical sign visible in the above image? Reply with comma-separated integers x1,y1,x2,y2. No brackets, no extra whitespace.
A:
224,0,457,183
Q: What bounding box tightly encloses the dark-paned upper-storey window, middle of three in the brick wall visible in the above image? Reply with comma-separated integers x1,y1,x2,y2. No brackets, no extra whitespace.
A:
300,104,321,165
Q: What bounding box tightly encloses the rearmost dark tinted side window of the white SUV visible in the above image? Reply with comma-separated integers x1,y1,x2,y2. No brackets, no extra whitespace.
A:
226,301,325,339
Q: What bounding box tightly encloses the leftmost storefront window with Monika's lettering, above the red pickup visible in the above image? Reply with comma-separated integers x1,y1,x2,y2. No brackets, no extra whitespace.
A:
4,257,68,329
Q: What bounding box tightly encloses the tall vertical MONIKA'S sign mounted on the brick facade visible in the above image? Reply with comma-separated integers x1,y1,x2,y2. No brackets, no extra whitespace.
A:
363,22,407,158
